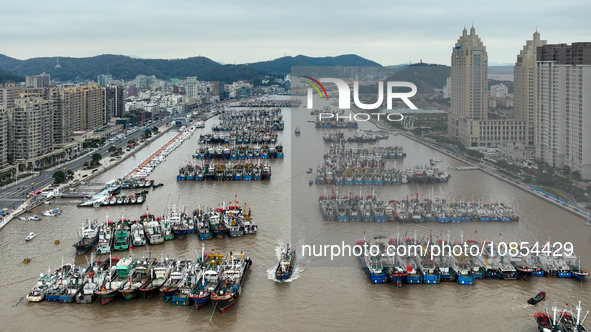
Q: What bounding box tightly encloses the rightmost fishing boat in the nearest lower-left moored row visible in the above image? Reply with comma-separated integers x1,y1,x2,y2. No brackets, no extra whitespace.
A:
211,252,252,313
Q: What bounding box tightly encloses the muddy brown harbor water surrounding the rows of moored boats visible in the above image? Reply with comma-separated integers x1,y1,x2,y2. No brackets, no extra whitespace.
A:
0,97,591,331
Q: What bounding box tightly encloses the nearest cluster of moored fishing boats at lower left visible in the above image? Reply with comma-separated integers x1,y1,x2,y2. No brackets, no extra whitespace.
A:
26,247,252,312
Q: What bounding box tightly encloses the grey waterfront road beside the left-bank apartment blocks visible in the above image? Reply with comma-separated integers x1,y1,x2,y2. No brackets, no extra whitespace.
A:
0,118,172,210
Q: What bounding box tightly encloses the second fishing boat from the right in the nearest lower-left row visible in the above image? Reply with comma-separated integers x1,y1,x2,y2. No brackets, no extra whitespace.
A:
189,249,224,309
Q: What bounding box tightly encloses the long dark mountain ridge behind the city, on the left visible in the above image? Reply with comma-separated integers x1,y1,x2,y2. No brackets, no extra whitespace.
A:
0,54,381,83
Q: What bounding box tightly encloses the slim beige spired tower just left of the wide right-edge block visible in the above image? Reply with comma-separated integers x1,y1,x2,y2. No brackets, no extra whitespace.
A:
513,31,546,146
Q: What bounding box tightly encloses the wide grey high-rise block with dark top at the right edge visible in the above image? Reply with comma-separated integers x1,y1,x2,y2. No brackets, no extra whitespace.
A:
535,42,591,179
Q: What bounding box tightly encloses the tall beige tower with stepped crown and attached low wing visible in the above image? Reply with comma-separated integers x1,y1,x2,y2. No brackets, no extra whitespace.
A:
447,27,525,147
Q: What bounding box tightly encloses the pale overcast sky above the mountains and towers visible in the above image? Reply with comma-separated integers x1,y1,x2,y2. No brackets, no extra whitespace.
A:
0,0,591,65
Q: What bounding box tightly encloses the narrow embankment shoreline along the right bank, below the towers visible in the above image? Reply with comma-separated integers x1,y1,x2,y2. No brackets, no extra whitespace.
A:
351,106,591,220
